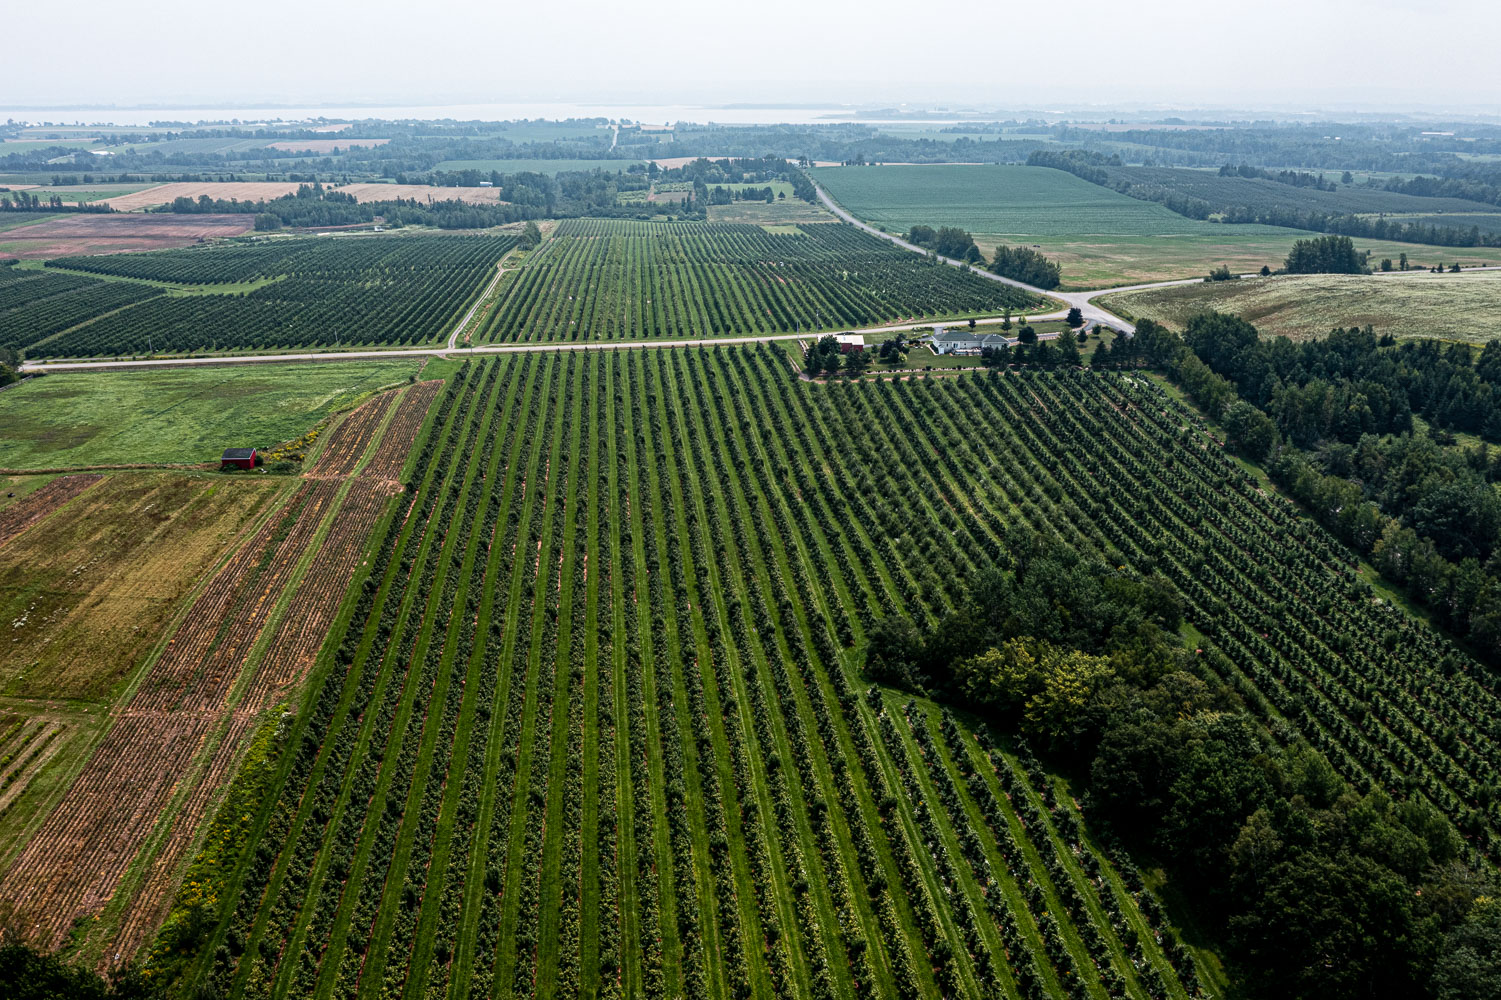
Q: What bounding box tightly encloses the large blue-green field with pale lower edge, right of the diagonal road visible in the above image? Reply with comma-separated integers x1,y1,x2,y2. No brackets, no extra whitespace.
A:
812,167,1501,288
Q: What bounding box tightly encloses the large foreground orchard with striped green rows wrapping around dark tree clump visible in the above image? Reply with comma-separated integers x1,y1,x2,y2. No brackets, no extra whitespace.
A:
138,344,1501,1000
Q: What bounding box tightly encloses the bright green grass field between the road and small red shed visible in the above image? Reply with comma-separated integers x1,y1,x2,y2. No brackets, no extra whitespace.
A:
0,359,422,468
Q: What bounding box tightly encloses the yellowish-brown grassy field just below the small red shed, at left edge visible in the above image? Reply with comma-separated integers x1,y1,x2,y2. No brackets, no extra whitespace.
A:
0,473,285,701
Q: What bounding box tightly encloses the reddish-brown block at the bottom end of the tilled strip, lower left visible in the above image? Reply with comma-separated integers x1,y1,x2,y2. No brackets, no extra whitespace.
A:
0,712,215,950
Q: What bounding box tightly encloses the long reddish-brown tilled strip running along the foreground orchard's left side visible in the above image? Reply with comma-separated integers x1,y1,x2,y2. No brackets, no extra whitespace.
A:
0,383,417,962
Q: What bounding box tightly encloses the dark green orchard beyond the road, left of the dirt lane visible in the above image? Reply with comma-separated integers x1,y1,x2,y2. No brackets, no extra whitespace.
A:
14,234,516,357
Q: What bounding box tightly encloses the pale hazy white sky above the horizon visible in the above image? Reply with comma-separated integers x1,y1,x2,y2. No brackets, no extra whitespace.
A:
11,0,1501,111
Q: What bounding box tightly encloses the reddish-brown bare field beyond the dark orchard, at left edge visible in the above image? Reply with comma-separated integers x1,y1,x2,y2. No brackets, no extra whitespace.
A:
0,213,255,258
